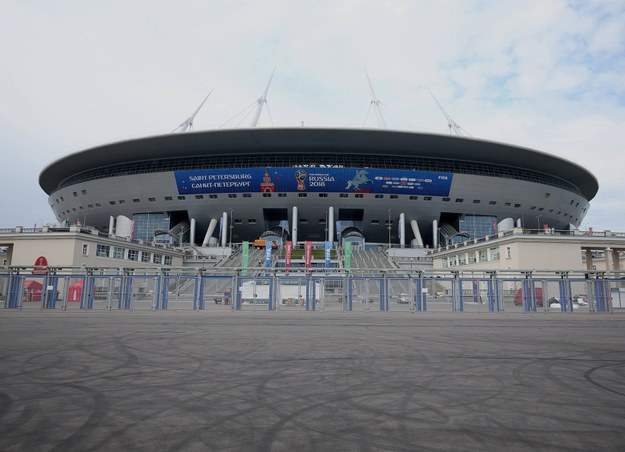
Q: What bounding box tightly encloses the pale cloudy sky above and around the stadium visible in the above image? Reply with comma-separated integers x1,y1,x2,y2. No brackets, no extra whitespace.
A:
0,0,625,232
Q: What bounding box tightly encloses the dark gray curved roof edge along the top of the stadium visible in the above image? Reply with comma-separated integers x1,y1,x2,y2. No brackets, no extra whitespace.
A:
39,127,599,201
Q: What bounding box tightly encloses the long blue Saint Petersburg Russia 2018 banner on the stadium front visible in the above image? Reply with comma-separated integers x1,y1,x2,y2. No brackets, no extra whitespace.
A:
174,168,453,196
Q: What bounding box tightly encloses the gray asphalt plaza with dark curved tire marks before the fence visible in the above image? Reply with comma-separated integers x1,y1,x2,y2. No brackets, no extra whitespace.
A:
0,311,625,451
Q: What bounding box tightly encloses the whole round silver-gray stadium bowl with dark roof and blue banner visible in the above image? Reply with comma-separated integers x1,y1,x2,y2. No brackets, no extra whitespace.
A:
39,127,598,247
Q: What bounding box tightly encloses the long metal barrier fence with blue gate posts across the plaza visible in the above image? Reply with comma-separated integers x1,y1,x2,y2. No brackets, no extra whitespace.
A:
0,267,625,313
